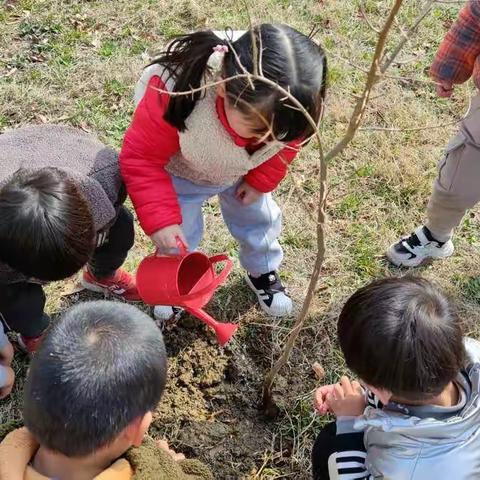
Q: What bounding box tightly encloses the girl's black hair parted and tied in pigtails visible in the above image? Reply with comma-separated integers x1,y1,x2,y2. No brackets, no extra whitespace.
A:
153,24,327,142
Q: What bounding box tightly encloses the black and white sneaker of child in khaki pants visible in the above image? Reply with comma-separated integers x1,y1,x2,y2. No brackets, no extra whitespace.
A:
386,226,454,267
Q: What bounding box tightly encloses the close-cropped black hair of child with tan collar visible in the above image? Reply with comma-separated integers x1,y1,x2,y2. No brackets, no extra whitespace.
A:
23,301,167,457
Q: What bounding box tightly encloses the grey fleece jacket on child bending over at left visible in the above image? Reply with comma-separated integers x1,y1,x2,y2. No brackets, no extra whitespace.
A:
0,125,125,283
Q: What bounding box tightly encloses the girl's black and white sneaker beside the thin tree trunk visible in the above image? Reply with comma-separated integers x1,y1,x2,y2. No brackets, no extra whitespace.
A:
245,272,293,317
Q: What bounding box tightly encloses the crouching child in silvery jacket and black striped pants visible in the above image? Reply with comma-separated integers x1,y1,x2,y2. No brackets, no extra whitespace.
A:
312,277,480,480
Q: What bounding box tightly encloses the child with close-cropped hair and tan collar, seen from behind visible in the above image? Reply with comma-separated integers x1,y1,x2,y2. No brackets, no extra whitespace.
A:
0,301,213,480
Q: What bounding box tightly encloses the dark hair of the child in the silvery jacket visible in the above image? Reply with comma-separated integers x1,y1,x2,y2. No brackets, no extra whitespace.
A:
338,277,465,400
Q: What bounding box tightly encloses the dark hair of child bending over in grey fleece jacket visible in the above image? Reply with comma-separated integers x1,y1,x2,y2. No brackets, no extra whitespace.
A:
0,167,95,281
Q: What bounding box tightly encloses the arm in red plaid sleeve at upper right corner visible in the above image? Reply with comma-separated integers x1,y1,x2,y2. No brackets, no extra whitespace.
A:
430,0,480,96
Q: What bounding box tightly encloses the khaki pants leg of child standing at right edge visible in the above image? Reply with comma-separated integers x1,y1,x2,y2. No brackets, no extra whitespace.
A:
426,94,480,242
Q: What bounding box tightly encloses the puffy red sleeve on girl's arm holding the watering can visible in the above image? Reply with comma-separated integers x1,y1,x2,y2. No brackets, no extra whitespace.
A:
120,76,182,246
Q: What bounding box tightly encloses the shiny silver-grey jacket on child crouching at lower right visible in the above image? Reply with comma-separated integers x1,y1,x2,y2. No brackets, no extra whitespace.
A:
348,338,480,480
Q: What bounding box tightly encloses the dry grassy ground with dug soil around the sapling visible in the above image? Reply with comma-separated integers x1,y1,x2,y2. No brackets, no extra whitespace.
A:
0,0,480,479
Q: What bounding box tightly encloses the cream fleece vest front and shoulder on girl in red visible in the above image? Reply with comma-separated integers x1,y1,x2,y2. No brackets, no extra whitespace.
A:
134,65,284,186
